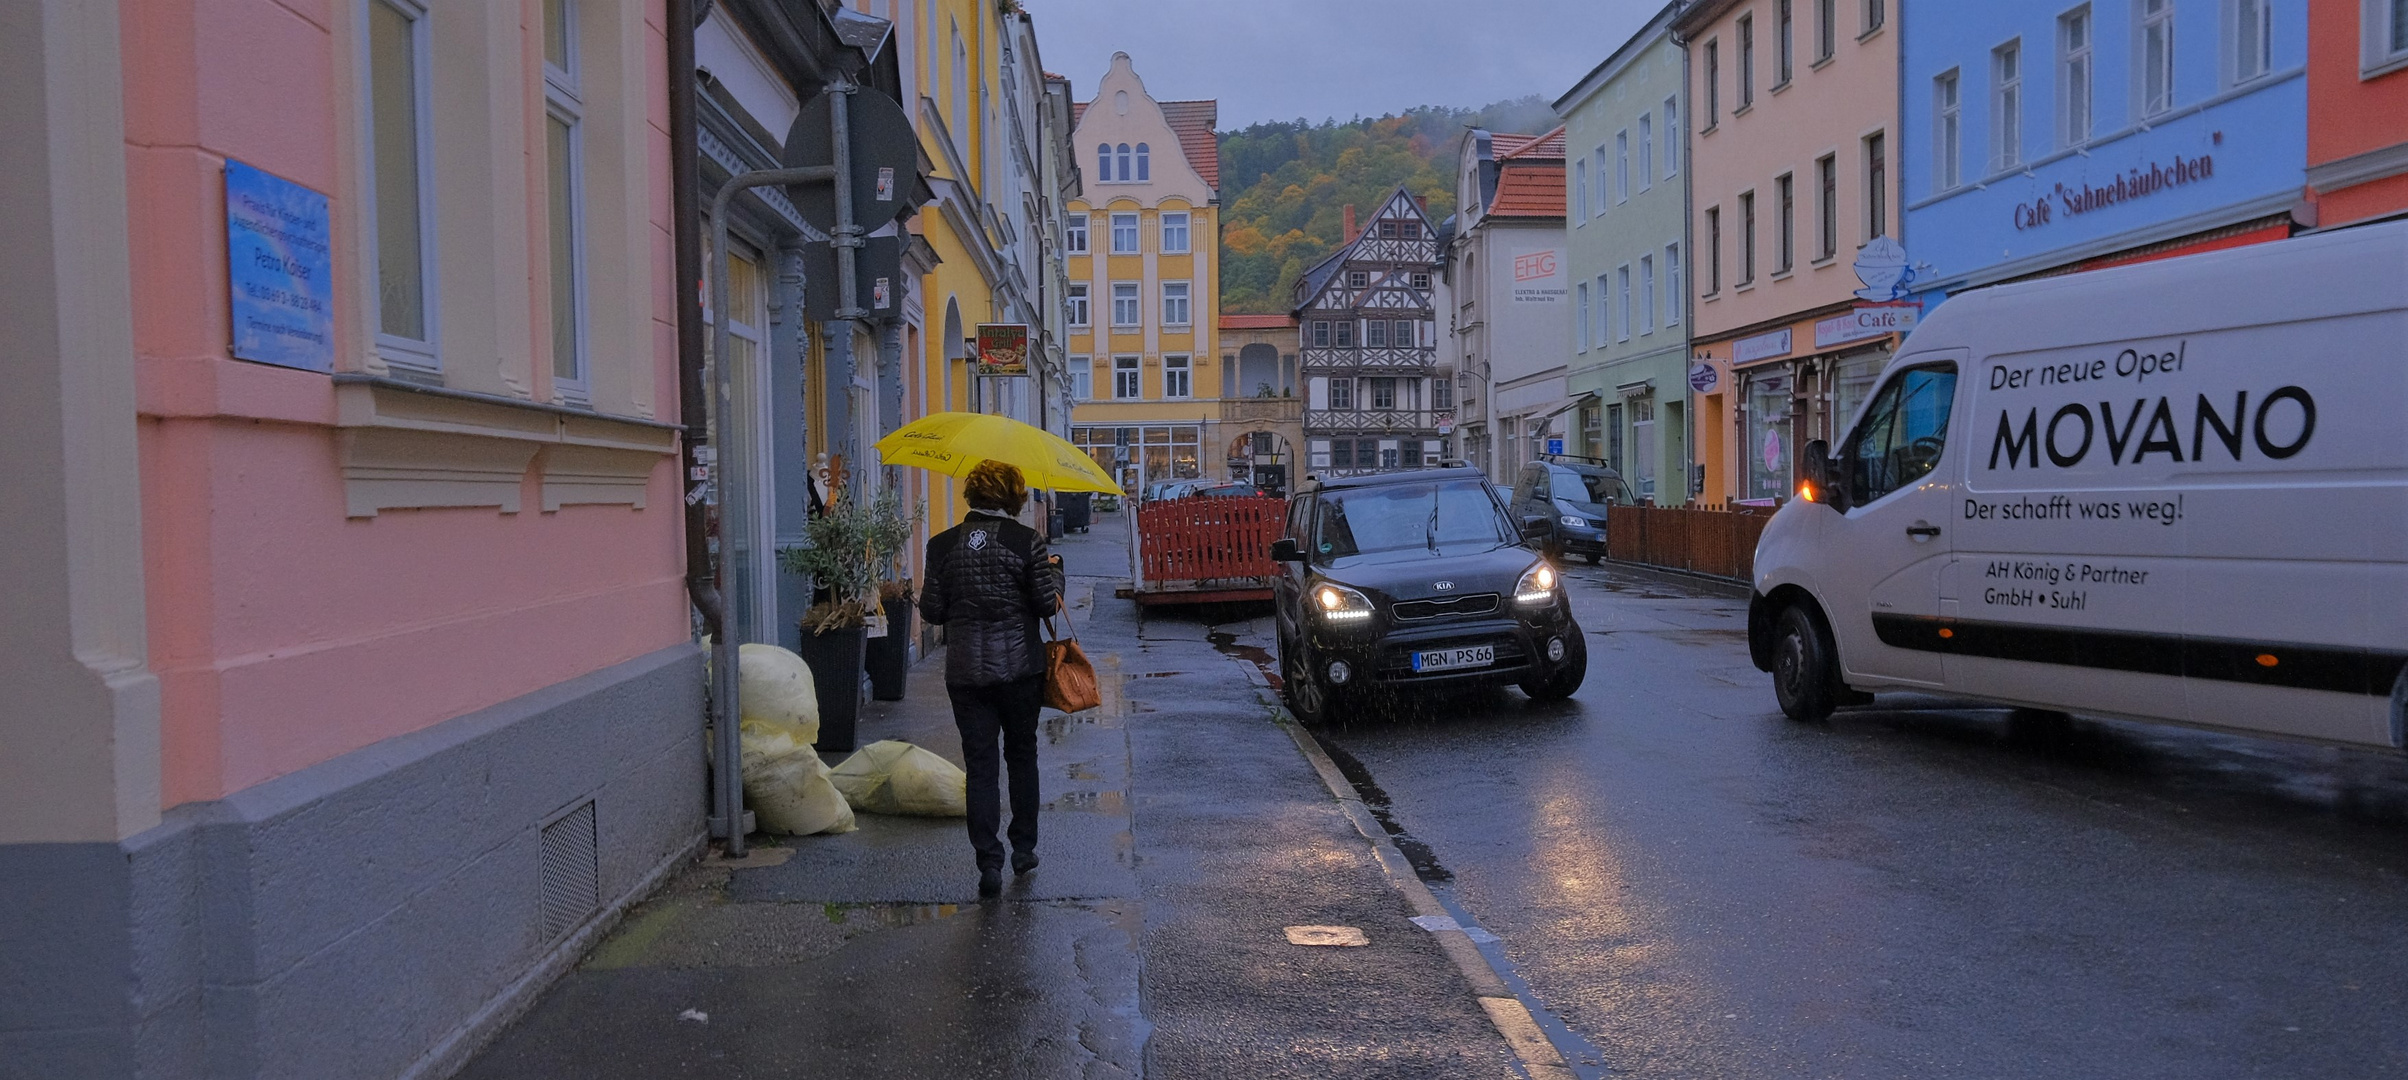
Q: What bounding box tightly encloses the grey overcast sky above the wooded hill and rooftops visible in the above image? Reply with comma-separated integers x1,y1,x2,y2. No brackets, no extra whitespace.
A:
1023,0,1664,130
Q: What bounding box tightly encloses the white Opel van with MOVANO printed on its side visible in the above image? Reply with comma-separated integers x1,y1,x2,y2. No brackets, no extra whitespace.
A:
1748,224,2408,748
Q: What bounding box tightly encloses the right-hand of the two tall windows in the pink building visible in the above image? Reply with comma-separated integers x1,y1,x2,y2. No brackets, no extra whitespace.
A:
544,0,588,399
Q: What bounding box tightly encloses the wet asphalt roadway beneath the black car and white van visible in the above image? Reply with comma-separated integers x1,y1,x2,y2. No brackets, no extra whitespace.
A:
1300,568,2408,1078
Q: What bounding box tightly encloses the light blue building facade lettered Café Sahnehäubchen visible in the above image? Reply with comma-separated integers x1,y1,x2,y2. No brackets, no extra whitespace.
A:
1900,0,2307,305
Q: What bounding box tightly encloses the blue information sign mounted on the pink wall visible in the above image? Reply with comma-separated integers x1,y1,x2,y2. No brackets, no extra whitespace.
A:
226,159,335,373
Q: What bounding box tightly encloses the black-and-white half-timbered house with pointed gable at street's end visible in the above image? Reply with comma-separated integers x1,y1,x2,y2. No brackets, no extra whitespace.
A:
1293,188,1454,476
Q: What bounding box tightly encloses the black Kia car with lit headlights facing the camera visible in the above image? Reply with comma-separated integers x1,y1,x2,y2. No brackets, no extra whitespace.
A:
1271,467,1589,724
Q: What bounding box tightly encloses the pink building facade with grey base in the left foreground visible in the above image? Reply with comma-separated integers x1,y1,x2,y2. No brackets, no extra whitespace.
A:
0,0,703,1078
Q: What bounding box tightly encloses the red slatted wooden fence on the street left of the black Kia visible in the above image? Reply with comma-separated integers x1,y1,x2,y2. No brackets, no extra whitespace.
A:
1137,498,1288,601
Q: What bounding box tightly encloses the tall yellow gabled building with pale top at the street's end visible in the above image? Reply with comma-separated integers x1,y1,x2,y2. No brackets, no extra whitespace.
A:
1064,53,1235,493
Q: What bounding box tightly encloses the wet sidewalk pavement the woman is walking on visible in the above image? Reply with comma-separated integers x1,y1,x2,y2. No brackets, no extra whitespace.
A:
460,515,1519,1080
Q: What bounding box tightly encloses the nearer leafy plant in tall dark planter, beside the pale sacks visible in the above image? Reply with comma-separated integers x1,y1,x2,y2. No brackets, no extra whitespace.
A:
778,498,877,750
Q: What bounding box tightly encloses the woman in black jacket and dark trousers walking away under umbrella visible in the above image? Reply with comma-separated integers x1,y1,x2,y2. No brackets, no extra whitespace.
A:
920,462,1062,897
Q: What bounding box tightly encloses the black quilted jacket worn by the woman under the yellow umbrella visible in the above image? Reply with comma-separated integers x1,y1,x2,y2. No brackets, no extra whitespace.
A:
920,512,1062,686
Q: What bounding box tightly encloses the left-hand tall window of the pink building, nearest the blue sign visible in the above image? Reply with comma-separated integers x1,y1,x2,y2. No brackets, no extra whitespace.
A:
368,0,436,368
